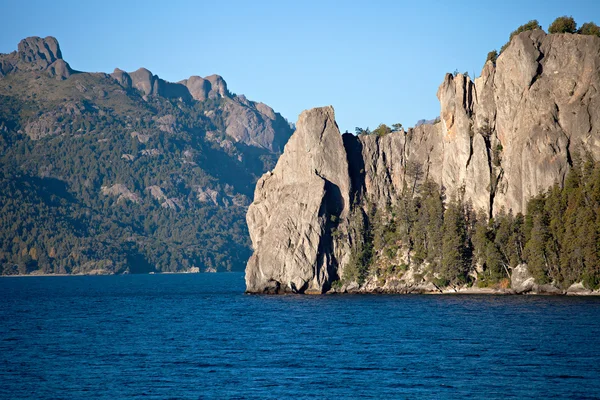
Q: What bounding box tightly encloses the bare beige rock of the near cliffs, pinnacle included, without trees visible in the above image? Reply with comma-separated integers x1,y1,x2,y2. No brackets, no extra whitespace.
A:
246,30,600,292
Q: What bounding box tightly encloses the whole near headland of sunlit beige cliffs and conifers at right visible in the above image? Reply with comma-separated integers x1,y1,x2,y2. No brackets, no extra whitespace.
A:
246,29,600,293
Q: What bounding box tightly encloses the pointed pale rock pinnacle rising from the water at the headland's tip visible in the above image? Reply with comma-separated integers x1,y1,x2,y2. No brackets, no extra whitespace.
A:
246,107,350,293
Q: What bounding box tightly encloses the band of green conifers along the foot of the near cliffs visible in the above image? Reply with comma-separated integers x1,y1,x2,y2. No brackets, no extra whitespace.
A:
340,155,600,289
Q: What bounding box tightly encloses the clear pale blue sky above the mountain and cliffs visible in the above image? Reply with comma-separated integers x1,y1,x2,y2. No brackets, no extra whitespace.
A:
0,0,600,131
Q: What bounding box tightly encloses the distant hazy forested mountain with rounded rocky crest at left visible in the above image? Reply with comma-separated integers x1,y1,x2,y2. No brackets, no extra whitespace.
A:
0,37,292,274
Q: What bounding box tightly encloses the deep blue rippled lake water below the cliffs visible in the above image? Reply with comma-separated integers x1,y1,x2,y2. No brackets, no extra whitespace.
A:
0,273,600,399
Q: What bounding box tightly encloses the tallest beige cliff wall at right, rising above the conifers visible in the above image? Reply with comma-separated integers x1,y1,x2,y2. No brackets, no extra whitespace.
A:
438,30,600,214
